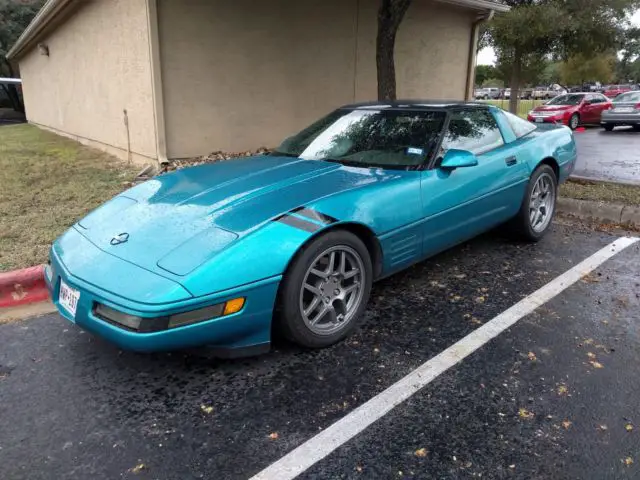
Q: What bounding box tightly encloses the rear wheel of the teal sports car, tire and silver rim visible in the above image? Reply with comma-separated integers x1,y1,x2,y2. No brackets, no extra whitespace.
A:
512,164,558,242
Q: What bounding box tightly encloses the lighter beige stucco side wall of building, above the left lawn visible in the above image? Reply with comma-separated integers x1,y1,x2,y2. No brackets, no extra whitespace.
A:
19,0,156,161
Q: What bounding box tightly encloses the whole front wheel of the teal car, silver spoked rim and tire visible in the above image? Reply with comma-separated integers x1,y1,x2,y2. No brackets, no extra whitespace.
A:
277,230,373,348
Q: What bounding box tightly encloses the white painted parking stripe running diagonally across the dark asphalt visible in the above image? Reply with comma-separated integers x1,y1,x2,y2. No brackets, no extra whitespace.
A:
250,237,640,480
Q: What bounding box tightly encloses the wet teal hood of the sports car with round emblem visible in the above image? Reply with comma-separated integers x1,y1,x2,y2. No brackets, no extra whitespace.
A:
74,156,396,275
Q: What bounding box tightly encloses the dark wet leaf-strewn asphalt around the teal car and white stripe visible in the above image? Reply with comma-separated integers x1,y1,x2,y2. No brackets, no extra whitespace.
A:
0,224,640,479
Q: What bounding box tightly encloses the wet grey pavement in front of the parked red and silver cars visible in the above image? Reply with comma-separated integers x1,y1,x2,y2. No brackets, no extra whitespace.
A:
573,127,640,185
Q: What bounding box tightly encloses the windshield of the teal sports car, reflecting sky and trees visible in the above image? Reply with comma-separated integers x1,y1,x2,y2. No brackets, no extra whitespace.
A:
272,109,446,168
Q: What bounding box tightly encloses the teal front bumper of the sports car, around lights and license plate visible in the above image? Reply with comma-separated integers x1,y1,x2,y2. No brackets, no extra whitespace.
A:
45,249,280,356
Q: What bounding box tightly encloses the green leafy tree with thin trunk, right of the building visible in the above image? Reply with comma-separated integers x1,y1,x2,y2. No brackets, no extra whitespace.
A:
489,0,640,112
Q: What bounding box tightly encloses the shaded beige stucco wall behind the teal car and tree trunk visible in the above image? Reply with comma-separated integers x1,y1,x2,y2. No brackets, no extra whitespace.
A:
158,0,474,158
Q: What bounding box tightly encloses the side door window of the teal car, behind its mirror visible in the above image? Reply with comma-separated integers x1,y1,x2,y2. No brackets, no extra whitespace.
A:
442,108,504,155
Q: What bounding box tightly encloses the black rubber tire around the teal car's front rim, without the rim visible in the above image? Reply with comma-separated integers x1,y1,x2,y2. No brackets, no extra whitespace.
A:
275,230,373,348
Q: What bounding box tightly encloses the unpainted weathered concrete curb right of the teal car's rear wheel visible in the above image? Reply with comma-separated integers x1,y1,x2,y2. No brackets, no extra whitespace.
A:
557,197,640,228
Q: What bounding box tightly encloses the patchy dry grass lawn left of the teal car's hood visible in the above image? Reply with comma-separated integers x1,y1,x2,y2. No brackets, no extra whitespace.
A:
0,124,136,271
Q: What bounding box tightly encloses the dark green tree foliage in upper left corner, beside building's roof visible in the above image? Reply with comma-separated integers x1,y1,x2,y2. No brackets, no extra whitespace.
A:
0,0,44,111
